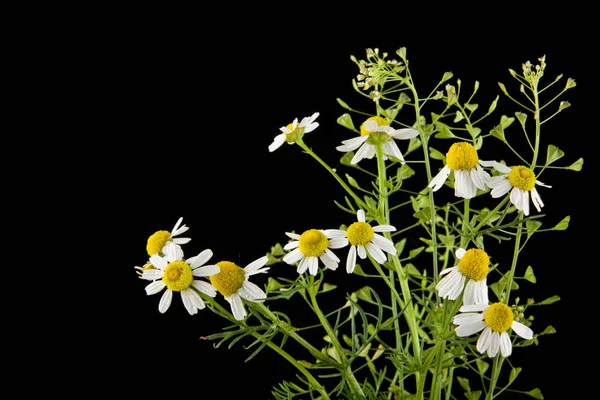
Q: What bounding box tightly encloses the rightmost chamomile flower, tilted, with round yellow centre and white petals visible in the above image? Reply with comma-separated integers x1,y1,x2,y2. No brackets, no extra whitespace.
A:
481,161,552,215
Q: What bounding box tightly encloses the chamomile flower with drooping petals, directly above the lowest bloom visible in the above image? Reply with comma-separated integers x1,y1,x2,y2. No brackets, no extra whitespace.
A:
435,248,490,305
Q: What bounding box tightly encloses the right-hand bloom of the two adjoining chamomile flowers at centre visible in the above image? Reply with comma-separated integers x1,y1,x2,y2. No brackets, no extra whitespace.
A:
336,210,397,274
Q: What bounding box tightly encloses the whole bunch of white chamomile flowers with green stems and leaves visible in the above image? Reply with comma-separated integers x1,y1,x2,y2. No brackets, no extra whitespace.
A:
136,48,583,400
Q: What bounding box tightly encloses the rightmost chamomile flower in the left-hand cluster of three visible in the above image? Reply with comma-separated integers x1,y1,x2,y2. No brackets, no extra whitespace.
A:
210,256,269,321
